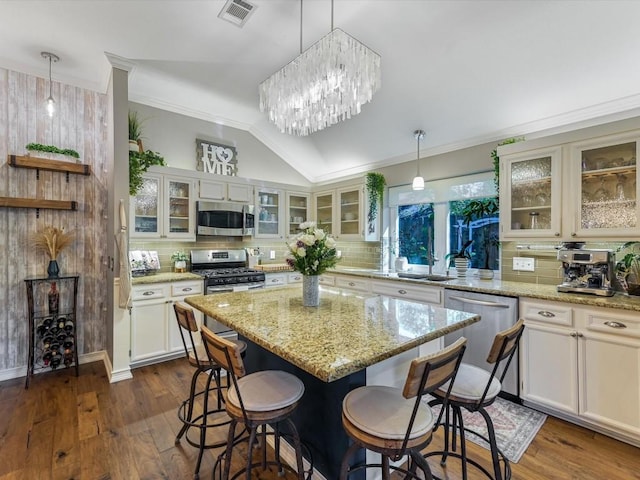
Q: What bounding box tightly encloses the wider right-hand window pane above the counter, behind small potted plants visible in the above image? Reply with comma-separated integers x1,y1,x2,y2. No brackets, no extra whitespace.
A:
449,197,499,270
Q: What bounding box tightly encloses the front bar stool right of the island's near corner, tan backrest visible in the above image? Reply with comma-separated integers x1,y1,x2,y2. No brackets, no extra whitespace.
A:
340,337,467,480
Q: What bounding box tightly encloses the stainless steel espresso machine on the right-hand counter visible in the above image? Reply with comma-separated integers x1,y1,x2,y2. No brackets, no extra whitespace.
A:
558,248,614,297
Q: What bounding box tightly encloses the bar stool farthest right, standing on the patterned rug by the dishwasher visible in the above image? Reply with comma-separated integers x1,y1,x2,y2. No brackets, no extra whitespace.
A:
425,319,524,480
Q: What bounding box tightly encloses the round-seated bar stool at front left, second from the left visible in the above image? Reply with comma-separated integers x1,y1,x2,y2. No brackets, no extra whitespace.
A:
201,327,313,480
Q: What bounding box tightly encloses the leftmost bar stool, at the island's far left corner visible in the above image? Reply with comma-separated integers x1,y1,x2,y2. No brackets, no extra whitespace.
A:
173,303,247,479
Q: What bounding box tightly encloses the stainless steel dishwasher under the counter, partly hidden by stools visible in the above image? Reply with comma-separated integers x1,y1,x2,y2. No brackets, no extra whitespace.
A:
444,290,520,399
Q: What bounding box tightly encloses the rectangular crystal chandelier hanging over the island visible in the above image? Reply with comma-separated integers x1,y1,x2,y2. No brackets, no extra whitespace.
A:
259,0,381,136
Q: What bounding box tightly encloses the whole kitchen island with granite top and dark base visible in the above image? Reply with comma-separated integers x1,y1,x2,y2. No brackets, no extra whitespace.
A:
185,285,480,479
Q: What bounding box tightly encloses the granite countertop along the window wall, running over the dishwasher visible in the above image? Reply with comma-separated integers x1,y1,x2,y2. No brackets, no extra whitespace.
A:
330,267,640,312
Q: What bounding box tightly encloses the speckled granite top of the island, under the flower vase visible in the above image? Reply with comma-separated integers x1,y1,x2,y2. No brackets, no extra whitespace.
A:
185,285,480,382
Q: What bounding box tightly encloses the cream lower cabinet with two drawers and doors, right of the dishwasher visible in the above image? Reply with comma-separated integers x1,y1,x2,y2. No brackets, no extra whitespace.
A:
520,299,640,445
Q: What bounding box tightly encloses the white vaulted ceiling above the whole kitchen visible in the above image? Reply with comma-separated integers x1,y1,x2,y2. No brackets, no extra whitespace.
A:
0,0,640,182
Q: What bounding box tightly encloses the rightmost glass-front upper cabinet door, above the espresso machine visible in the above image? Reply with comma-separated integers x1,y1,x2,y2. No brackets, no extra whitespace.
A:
566,132,640,237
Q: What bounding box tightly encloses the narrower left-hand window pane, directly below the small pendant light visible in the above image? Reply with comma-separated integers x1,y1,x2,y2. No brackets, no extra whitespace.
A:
398,203,434,265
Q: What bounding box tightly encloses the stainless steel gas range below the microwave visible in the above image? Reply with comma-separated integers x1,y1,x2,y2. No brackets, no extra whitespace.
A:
191,249,265,336
